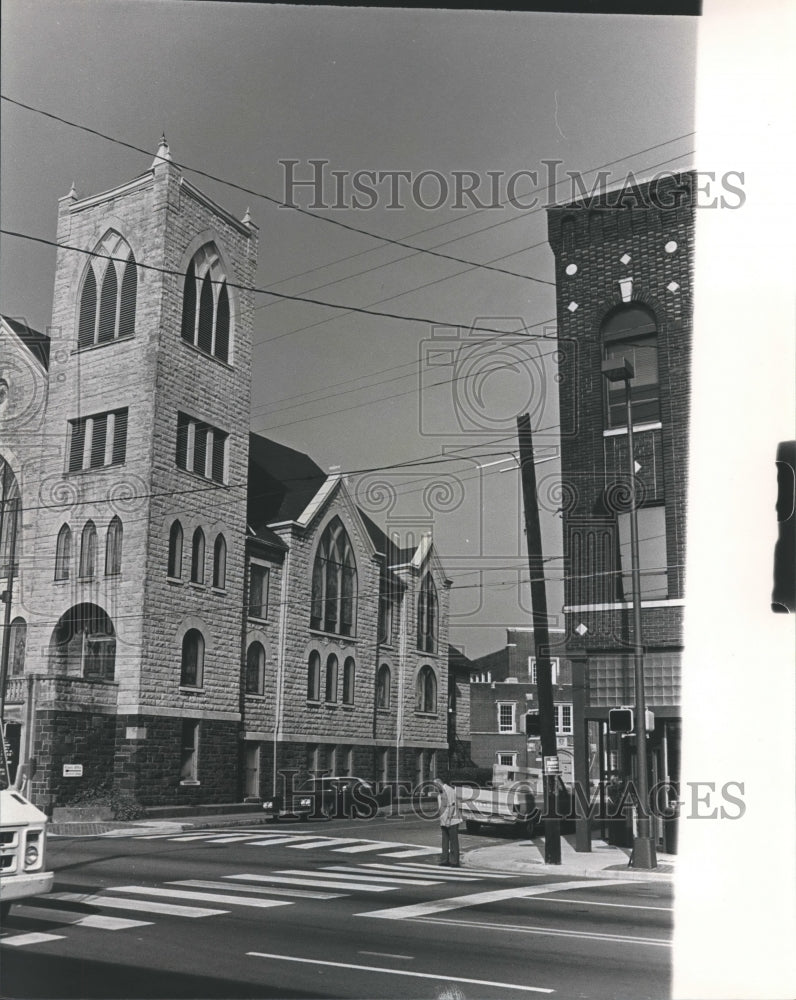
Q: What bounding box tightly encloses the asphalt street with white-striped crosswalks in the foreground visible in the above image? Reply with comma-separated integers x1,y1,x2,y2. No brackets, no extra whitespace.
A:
0,818,672,1000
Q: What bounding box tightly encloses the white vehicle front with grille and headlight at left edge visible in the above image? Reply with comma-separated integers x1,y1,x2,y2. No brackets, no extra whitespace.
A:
0,787,53,917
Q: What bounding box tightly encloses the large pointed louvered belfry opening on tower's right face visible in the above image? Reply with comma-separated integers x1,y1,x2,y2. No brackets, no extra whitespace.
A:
182,243,230,361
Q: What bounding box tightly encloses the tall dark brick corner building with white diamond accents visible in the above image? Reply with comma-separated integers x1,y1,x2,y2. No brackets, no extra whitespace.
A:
548,173,695,849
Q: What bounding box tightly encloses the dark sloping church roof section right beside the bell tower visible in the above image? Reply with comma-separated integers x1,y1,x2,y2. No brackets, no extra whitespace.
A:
247,434,327,536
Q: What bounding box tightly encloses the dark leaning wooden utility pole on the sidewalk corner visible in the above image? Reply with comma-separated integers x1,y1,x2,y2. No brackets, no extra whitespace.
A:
517,413,561,865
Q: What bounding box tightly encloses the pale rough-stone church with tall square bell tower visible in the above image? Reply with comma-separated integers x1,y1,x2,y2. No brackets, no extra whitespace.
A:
0,139,449,808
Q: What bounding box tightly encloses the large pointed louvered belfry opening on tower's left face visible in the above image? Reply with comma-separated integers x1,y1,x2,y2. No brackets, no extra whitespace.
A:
77,229,138,350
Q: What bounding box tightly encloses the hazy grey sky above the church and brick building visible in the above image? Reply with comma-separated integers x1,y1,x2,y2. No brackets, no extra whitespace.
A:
0,0,696,655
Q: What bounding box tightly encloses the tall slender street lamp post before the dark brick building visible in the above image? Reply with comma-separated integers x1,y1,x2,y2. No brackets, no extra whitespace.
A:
602,358,658,870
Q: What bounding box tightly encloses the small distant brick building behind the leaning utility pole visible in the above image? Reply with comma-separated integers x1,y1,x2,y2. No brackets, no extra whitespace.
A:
470,628,574,783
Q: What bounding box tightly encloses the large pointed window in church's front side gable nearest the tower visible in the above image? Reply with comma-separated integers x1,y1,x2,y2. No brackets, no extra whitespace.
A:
310,517,357,635
